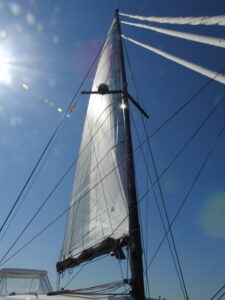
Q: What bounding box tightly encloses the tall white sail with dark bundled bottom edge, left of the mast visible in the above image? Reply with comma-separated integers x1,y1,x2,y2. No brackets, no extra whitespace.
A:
57,21,128,271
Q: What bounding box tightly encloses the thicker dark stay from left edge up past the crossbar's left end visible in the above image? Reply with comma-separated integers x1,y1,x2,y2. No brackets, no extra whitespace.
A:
0,39,104,237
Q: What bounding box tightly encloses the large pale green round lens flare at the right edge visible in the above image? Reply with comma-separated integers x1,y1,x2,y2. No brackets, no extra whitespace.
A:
200,191,225,239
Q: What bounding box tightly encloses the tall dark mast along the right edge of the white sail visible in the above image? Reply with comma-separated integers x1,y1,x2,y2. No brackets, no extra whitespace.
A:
115,9,145,300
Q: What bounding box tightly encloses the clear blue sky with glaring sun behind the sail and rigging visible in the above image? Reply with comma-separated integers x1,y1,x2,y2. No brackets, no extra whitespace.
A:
0,0,225,300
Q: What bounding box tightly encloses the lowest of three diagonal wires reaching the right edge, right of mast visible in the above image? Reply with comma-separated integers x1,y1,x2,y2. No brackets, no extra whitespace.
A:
147,125,225,271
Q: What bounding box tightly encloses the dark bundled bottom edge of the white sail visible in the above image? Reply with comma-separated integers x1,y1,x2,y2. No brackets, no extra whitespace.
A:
56,236,129,273
